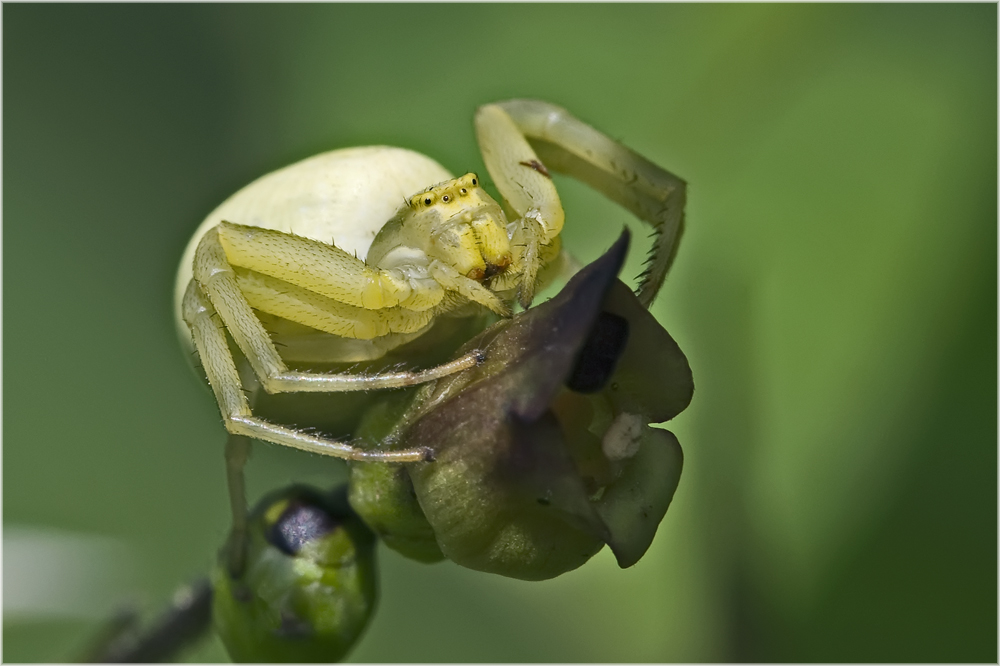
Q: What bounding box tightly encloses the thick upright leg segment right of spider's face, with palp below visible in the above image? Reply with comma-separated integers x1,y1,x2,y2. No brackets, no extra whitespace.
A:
476,104,565,308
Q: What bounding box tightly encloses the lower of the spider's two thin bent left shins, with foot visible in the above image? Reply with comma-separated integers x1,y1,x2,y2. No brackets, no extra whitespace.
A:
182,280,438,462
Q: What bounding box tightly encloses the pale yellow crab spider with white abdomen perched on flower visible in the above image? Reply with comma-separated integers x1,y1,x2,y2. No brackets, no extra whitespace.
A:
175,100,685,466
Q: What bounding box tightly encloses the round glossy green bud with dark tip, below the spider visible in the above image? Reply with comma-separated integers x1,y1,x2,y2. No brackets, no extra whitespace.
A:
212,486,377,662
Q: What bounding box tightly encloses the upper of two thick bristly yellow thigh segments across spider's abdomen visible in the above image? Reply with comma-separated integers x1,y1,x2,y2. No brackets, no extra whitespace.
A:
219,222,444,310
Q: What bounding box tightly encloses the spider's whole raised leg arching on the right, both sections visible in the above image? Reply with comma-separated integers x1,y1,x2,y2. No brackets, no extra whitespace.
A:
476,99,686,307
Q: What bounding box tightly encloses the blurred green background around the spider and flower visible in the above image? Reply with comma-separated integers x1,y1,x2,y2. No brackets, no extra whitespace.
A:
3,4,997,662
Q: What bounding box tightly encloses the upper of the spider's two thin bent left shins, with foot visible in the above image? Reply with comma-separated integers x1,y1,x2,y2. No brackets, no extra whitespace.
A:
192,225,482,394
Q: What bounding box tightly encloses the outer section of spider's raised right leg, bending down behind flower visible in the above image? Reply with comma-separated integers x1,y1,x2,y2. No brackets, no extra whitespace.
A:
486,99,687,307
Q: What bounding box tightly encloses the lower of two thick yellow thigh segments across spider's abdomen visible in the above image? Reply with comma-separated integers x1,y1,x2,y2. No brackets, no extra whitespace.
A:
234,268,434,340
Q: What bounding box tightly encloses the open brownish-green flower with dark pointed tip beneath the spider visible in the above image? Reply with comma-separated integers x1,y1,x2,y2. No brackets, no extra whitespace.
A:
352,231,693,580
